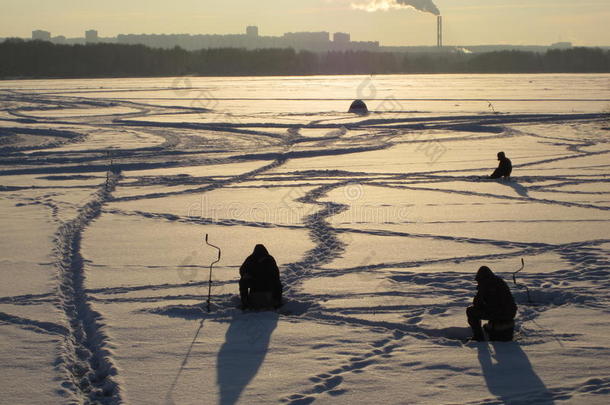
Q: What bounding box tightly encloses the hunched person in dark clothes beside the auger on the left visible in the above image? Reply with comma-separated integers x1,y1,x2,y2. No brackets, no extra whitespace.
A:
239,244,282,309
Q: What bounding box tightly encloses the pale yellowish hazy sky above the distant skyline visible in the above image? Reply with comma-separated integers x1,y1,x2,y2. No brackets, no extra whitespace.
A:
0,0,610,46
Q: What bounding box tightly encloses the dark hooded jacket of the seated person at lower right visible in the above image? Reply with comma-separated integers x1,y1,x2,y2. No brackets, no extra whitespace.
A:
473,266,517,320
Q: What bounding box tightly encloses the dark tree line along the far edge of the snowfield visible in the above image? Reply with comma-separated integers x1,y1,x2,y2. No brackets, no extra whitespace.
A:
0,39,610,79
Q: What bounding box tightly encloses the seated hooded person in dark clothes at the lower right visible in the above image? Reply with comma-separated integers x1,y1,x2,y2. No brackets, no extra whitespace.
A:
466,266,517,341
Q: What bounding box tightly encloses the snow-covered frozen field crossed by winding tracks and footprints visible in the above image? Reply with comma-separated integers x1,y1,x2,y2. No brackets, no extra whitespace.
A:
0,75,610,405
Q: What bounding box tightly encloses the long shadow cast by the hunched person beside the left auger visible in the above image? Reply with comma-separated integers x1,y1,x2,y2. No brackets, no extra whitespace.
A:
216,312,279,405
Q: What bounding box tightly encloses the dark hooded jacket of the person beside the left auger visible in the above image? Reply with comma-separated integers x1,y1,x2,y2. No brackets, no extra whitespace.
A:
239,245,282,299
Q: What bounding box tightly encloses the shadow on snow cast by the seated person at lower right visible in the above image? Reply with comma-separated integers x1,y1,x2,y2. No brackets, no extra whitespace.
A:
478,342,555,405
